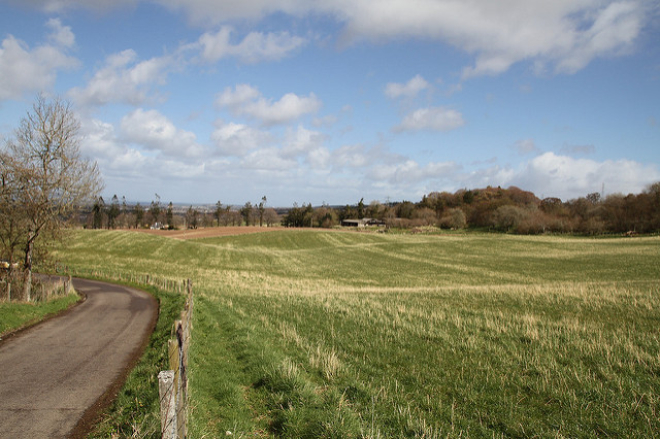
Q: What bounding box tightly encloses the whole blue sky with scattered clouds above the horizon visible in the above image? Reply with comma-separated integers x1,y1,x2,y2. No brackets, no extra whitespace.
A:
0,0,660,207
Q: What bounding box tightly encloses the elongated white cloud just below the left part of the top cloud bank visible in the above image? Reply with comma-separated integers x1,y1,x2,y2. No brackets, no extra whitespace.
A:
198,26,305,64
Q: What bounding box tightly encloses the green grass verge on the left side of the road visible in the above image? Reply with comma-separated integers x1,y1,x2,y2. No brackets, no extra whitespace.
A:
0,293,80,336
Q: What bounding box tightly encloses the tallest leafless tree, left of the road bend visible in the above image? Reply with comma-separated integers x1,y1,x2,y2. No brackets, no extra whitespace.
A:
1,96,103,300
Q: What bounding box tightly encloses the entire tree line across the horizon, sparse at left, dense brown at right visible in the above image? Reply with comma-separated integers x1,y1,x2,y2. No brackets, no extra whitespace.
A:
86,182,660,235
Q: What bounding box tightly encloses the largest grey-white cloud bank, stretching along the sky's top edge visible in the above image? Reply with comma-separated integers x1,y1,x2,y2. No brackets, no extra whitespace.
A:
159,0,654,78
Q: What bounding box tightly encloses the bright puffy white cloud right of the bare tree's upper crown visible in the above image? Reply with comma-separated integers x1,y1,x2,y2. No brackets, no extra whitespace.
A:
120,108,205,157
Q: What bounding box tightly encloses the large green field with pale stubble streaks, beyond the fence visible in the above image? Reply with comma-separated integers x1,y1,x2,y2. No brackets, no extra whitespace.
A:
56,230,660,438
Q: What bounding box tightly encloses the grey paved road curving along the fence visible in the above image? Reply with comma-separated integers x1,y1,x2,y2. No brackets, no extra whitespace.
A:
0,279,158,439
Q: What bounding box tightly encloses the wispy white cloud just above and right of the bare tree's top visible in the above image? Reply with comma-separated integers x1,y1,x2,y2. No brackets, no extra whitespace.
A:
70,49,172,106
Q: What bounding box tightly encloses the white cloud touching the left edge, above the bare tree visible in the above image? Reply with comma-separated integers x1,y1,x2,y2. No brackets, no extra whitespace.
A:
0,19,79,100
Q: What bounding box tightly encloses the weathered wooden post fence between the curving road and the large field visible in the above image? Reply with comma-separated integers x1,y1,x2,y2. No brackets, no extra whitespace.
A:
65,270,194,439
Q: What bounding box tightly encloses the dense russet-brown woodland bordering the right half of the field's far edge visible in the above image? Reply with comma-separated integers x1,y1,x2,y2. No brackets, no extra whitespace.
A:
282,182,660,234
